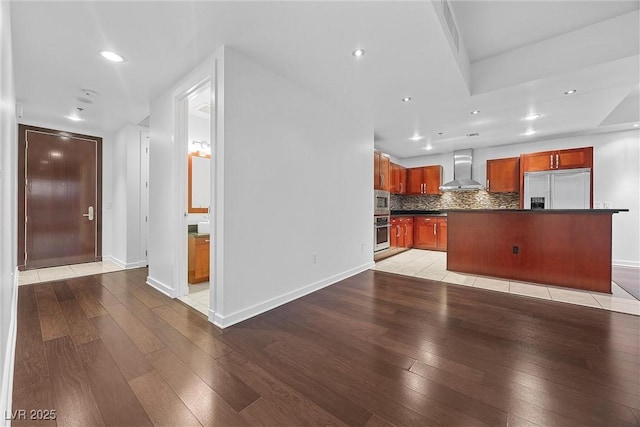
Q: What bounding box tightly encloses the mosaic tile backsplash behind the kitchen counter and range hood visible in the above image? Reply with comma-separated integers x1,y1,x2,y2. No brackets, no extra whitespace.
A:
391,190,520,211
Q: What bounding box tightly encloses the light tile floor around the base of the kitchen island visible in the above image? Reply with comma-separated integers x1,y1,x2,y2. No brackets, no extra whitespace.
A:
373,249,640,316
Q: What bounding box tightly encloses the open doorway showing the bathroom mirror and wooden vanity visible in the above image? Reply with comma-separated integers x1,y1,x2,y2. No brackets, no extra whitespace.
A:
178,80,215,316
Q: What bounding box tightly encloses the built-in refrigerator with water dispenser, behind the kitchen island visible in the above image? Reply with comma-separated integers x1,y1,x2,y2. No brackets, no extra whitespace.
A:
524,168,591,209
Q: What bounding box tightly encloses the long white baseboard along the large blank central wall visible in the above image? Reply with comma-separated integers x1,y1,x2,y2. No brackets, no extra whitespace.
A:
210,261,375,328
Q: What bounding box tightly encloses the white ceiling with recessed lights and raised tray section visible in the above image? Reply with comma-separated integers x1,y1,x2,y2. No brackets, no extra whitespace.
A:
11,0,640,158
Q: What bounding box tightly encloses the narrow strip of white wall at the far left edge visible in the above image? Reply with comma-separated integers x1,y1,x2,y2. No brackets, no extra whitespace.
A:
0,2,18,425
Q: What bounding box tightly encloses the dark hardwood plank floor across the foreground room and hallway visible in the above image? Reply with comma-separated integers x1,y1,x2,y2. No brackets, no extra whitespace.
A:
13,269,640,427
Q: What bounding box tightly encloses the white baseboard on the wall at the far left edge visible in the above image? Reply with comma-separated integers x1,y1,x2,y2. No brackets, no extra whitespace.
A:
0,267,18,426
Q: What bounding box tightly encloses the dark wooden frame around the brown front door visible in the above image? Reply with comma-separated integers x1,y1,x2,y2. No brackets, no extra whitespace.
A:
17,124,102,270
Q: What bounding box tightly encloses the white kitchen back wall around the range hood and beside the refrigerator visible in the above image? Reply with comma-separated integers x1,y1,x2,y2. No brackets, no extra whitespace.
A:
400,130,640,267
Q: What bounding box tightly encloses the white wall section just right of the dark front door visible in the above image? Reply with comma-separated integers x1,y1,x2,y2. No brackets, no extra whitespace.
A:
103,125,146,268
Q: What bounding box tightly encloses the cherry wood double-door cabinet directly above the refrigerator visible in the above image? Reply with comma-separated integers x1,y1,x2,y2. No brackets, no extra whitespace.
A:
520,147,593,173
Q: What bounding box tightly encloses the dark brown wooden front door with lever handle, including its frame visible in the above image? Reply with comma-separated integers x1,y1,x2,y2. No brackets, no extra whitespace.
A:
19,125,102,269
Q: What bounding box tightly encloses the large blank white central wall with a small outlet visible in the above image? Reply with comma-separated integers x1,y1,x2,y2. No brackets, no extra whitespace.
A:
215,47,373,326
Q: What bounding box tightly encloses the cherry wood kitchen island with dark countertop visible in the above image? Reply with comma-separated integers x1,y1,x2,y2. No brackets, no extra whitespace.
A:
447,209,628,293
